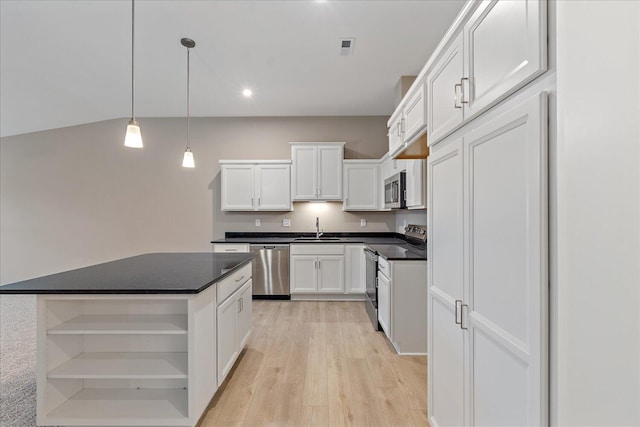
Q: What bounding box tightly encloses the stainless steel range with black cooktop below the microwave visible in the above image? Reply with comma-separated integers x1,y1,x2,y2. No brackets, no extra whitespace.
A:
364,224,427,331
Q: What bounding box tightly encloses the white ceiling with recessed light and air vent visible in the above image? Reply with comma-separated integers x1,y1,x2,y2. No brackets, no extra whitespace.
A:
0,0,464,136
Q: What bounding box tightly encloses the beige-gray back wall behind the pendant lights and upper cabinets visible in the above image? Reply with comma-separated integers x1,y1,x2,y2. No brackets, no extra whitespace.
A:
0,117,396,284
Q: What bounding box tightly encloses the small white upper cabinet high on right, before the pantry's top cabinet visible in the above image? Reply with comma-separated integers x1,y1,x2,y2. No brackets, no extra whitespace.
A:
387,81,427,157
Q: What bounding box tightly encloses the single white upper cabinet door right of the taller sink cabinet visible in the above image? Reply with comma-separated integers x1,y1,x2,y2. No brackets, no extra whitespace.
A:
343,162,380,211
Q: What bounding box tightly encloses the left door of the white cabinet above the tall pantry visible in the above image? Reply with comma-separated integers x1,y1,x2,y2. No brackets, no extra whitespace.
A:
427,33,464,145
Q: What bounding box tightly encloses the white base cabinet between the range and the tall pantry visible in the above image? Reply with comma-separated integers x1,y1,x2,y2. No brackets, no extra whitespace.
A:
378,257,427,355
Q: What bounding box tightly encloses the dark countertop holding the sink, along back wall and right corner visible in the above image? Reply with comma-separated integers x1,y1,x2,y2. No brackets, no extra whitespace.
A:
211,232,427,261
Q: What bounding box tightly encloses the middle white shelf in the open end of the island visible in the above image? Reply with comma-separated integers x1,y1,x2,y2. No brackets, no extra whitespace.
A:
47,353,188,379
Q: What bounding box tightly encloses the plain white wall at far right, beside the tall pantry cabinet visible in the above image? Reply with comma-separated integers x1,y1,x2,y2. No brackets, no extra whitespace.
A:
557,1,640,426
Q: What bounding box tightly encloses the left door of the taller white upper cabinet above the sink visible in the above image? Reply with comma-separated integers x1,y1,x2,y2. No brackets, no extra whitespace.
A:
291,145,318,200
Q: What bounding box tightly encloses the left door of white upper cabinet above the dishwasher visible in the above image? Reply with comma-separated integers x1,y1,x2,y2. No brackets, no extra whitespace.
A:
220,165,255,211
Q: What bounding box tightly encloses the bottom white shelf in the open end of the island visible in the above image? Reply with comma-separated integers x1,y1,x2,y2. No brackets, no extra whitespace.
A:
47,389,189,426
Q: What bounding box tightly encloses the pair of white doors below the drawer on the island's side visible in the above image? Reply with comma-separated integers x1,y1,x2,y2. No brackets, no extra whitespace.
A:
217,279,252,386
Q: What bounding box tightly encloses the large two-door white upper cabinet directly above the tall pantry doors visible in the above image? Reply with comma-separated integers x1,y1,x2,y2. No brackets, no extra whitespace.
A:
424,0,547,145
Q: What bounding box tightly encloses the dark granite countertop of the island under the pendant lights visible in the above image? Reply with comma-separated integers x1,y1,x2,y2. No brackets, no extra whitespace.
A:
0,253,253,294
